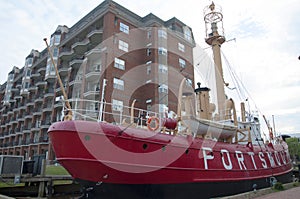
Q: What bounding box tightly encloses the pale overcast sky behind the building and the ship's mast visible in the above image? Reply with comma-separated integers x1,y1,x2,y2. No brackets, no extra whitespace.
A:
0,0,300,133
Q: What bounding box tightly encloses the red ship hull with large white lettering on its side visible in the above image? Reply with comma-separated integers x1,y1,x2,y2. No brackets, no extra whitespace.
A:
49,121,292,197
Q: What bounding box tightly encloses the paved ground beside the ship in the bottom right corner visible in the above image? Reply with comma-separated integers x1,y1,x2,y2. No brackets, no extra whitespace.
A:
256,187,300,199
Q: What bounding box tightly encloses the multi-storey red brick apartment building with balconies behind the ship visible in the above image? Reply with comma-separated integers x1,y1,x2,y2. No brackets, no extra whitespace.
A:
0,0,195,160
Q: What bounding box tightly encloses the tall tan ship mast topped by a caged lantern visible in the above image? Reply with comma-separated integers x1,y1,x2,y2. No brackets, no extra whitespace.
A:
204,2,228,119
